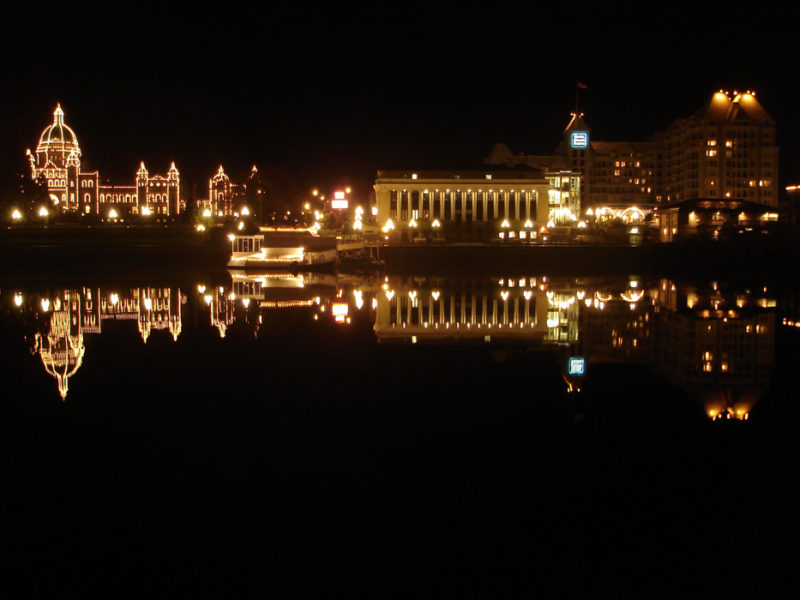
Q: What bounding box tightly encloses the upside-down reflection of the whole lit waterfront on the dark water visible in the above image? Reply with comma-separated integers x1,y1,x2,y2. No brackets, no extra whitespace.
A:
2,271,780,420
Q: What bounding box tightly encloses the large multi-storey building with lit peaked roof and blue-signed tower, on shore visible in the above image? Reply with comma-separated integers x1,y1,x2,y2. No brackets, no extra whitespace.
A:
487,91,778,214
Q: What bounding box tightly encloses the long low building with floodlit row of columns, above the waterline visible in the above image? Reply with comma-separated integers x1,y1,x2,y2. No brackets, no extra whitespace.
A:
374,169,581,234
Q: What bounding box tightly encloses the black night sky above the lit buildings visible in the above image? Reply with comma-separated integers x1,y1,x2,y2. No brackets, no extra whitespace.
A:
0,3,800,199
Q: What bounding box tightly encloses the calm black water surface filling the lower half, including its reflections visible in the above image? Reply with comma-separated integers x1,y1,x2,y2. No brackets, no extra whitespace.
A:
0,272,800,596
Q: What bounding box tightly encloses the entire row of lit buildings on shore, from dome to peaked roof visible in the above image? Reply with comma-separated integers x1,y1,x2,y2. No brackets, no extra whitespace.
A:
12,91,778,241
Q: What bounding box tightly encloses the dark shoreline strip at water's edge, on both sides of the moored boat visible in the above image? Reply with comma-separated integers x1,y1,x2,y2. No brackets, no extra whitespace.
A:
0,225,800,279
